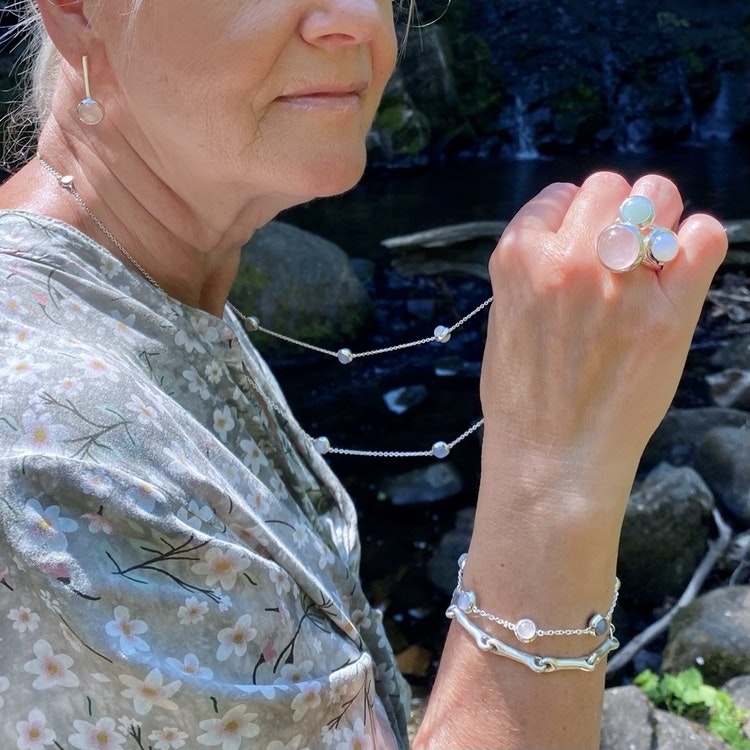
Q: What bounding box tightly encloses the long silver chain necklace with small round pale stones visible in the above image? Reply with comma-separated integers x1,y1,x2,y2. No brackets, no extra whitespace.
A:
37,154,492,459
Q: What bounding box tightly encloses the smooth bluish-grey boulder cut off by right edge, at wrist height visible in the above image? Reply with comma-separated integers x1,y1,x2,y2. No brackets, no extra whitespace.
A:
694,427,750,524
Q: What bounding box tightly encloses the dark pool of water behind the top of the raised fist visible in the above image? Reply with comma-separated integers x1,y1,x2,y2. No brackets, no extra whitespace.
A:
282,141,750,259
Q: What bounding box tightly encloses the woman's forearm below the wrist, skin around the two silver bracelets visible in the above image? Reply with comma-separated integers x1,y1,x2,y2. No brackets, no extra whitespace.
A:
414,458,629,750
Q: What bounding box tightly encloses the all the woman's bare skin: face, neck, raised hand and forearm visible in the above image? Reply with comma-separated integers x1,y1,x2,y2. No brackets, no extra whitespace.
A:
0,0,727,750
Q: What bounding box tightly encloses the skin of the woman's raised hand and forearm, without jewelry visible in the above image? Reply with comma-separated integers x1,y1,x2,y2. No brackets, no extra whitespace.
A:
414,174,727,750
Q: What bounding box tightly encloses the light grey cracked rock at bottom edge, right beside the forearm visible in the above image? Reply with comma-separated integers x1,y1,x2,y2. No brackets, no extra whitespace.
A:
600,685,729,750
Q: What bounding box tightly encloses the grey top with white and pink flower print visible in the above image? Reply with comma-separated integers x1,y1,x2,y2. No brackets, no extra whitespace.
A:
0,212,407,750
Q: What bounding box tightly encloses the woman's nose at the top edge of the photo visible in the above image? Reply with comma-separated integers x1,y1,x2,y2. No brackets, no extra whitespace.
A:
300,0,392,49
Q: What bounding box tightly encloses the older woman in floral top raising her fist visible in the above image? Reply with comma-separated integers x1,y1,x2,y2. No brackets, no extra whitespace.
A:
0,0,726,750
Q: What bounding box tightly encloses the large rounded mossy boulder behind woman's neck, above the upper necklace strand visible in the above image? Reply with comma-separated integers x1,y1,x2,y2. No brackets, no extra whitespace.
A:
230,221,373,354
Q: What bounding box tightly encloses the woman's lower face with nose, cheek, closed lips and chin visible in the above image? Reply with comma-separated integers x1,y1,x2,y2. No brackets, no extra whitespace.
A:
91,0,396,216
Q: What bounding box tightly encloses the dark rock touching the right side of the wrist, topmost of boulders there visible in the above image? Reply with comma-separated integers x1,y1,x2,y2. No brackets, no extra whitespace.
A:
641,406,750,470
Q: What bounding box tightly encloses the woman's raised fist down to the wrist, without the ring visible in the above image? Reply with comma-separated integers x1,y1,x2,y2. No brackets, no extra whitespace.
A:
481,173,727,516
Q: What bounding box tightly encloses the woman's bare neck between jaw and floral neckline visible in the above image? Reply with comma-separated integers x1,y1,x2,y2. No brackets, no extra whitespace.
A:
0,117,286,316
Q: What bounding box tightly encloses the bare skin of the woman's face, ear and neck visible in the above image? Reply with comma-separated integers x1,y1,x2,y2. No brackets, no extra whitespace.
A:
0,0,396,314
